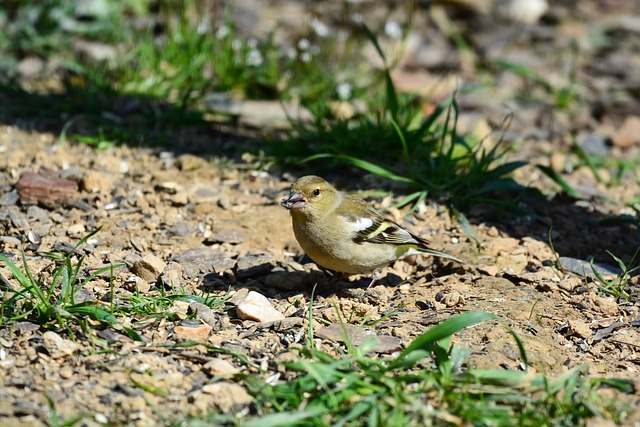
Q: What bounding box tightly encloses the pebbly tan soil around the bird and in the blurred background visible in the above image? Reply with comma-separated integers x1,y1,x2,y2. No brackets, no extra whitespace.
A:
0,0,640,426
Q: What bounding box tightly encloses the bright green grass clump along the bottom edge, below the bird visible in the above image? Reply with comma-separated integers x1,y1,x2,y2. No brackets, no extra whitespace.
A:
243,312,632,427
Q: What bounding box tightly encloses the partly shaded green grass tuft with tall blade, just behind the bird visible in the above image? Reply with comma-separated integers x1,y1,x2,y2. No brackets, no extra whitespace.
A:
272,26,527,210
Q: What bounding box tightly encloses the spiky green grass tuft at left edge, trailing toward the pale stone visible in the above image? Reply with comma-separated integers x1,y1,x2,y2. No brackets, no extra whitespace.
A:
0,228,227,340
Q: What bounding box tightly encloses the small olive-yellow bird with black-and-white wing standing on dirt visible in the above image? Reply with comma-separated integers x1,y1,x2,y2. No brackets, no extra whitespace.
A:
280,175,464,286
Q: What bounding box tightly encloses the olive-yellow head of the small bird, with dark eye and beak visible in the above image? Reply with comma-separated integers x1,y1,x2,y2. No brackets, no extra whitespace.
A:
280,175,340,216
